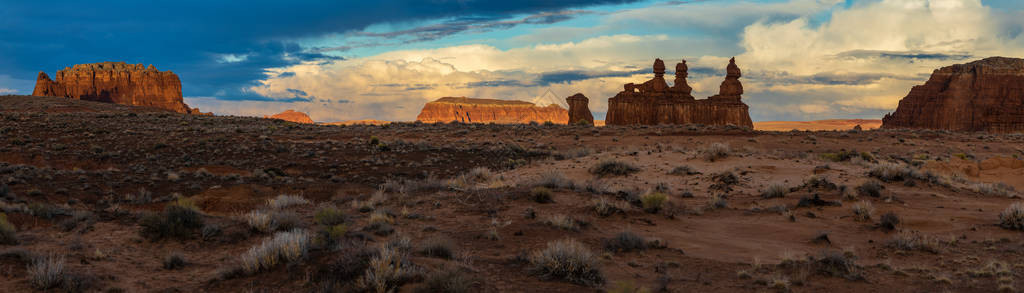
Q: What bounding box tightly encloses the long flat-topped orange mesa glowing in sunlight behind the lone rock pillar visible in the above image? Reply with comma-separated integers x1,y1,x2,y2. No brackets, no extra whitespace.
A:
416,97,568,124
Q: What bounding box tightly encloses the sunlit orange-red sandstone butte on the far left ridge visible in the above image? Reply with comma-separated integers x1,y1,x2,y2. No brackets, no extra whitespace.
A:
32,61,208,115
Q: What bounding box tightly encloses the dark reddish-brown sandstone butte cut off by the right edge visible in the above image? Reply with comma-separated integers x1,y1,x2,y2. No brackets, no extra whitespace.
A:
882,57,1024,133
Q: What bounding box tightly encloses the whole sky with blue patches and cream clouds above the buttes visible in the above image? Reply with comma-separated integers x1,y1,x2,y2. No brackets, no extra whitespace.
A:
0,0,1024,122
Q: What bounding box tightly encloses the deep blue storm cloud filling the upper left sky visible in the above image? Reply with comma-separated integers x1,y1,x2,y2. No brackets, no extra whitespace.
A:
0,0,632,99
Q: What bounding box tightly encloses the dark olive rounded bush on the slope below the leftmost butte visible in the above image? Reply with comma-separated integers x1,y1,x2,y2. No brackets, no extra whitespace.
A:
139,198,203,240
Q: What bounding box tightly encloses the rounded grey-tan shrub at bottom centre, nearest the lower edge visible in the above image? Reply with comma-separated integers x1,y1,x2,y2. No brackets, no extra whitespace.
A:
529,239,604,286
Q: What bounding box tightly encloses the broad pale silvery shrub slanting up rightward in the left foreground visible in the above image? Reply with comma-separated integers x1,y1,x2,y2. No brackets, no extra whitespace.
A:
241,229,309,274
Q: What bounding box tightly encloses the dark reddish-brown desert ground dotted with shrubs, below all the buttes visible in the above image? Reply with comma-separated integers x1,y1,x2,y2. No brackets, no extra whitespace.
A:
0,96,1024,292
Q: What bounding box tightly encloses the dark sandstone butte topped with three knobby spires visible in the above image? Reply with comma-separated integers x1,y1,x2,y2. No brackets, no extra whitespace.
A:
604,58,754,127
